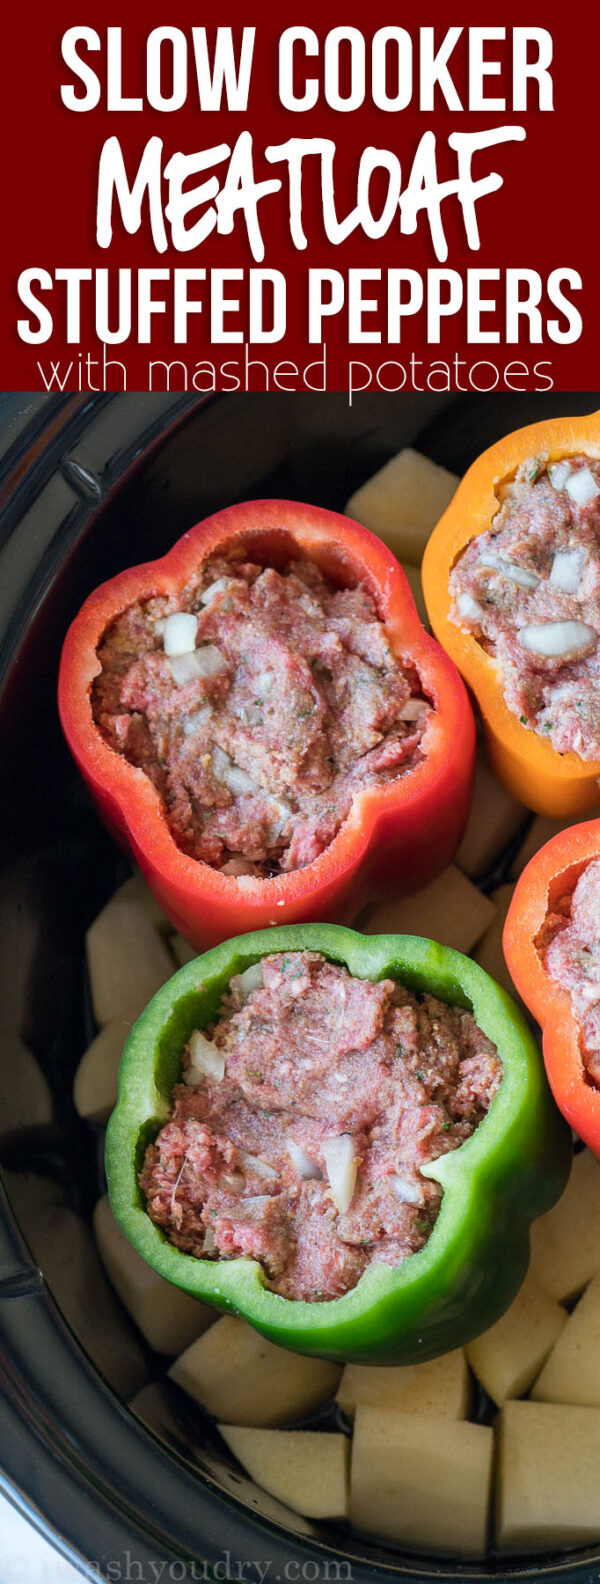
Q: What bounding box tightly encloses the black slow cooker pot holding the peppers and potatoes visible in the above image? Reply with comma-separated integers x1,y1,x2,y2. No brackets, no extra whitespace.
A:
0,391,600,1584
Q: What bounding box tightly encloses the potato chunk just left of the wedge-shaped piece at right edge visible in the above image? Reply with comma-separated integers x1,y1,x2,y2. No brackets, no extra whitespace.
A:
467,1275,567,1407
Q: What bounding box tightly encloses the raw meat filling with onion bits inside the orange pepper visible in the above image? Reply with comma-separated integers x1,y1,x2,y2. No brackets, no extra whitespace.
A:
450,456,600,760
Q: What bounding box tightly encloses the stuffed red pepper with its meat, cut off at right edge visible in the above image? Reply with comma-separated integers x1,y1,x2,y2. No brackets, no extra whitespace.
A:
503,819,600,1156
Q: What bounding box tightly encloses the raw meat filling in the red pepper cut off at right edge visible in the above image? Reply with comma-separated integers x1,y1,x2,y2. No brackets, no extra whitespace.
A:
538,859,600,1087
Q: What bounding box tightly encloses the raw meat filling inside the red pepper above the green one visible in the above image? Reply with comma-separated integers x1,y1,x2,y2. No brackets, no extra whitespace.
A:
92,558,431,879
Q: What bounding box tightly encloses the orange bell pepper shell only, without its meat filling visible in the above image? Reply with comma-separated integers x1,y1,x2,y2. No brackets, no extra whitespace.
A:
423,412,600,819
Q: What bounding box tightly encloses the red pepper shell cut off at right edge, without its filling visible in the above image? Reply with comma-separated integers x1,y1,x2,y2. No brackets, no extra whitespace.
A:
503,819,600,1156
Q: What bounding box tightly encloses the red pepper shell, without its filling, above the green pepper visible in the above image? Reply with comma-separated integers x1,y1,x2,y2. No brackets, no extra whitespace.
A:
59,501,475,947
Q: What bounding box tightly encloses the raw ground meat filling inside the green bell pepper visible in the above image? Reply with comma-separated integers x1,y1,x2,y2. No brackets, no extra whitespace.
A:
139,952,502,1300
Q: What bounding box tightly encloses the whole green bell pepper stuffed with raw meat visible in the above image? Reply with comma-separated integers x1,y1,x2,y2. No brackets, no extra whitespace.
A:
106,923,570,1364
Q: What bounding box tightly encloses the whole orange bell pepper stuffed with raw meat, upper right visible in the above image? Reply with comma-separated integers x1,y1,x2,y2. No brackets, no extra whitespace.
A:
423,402,600,817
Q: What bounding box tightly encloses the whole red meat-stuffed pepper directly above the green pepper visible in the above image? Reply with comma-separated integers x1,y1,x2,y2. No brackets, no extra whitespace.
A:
59,501,475,946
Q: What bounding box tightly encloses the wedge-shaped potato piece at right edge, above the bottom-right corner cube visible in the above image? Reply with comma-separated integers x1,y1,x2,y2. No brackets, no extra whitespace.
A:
532,1274,600,1408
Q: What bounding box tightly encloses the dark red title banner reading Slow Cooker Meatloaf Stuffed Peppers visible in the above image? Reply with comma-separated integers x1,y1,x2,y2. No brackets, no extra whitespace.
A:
2,0,600,399
